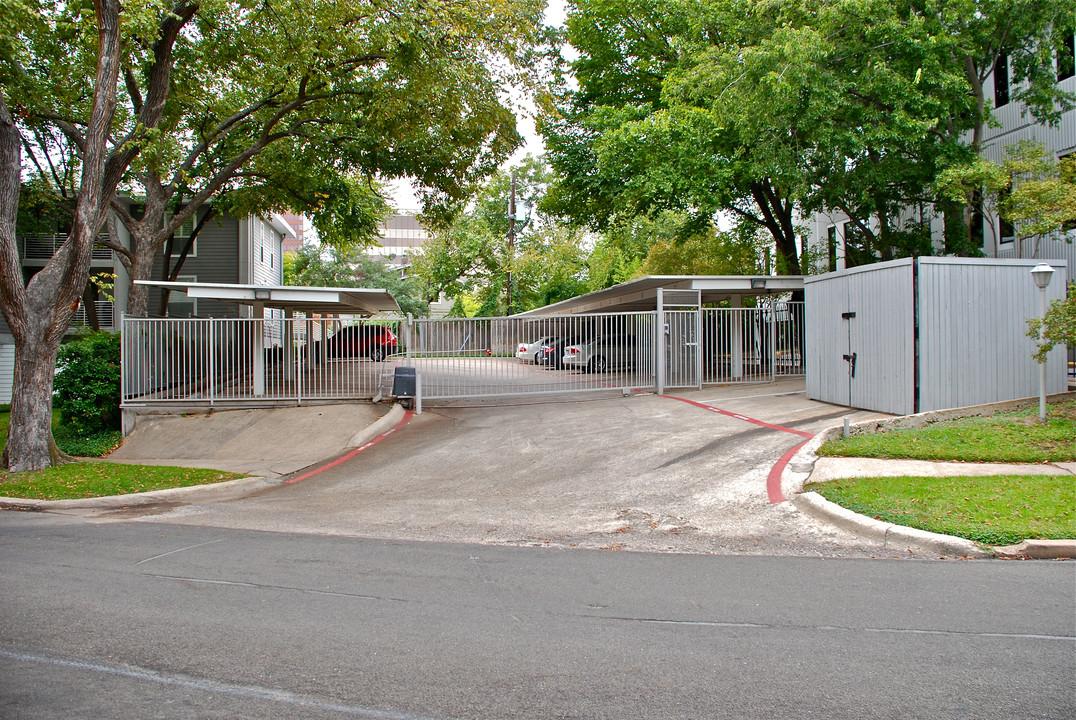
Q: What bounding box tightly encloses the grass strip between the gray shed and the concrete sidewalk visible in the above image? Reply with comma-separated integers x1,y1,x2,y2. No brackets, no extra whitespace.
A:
818,403,1076,463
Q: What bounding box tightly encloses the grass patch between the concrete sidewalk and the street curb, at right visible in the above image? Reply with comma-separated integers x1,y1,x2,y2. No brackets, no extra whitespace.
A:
805,475,1076,545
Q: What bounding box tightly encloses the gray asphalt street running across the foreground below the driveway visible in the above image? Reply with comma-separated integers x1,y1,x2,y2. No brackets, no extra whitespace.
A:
0,511,1076,720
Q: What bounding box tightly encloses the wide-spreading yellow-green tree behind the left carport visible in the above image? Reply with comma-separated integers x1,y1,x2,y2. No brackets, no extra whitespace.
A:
87,0,538,314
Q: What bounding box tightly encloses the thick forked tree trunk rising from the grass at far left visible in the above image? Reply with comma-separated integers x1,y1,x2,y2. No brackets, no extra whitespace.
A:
0,0,191,470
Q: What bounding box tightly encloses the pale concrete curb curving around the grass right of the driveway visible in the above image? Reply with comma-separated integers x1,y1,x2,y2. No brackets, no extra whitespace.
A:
781,392,1076,560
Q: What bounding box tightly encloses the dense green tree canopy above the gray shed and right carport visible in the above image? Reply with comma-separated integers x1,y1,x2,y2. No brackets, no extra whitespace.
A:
541,0,1076,273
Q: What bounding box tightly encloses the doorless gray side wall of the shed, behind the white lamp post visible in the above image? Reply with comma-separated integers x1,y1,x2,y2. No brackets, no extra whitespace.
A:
919,257,1067,411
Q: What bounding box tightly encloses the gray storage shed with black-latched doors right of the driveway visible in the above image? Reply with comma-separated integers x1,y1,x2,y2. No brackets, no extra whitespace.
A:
805,257,1068,414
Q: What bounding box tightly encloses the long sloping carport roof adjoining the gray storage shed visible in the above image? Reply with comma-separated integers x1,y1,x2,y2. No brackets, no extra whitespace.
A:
520,276,804,316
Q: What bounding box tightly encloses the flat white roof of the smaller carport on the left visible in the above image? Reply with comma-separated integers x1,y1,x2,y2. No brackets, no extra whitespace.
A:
135,280,400,315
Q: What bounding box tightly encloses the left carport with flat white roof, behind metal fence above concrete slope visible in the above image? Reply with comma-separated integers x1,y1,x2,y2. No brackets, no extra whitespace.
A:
122,281,399,407
